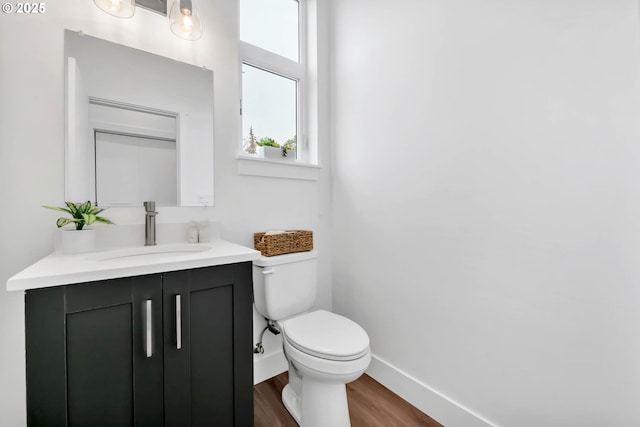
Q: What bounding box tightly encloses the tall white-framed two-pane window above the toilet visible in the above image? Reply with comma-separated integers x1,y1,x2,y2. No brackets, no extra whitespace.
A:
240,0,309,162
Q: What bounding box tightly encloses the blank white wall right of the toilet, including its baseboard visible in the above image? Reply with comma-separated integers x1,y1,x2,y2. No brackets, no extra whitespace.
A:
332,0,640,427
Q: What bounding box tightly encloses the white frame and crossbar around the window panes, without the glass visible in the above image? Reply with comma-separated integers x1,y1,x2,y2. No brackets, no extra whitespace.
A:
238,0,317,165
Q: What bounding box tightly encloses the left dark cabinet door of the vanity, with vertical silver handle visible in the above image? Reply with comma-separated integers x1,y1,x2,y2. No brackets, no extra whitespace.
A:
25,275,163,427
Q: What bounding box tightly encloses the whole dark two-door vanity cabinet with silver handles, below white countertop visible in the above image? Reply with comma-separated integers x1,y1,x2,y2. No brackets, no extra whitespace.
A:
25,262,253,427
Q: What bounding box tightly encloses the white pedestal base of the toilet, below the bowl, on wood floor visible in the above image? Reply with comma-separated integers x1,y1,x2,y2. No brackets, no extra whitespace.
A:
282,378,351,427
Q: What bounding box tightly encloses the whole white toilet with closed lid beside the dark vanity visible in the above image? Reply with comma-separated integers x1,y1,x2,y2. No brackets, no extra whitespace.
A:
253,251,371,427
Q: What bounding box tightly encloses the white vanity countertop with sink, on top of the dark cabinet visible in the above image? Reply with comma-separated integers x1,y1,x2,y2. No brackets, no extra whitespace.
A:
7,240,260,291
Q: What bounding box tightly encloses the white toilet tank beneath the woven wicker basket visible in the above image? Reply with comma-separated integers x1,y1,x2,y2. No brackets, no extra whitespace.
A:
253,251,318,320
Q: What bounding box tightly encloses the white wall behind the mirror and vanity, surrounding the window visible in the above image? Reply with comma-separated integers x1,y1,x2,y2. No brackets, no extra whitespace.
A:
0,0,331,427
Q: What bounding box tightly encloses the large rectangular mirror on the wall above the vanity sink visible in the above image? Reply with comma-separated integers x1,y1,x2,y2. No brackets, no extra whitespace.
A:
65,30,214,207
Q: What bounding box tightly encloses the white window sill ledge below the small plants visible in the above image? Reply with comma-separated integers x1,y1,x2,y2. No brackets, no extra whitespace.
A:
237,154,321,181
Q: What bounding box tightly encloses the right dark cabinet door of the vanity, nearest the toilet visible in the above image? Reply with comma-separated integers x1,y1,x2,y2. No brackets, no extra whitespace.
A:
163,263,253,427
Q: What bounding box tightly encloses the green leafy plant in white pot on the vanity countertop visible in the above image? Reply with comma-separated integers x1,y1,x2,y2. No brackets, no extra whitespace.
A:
43,201,113,253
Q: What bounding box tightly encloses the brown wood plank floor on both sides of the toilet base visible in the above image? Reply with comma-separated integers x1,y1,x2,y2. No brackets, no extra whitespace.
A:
253,372,442,427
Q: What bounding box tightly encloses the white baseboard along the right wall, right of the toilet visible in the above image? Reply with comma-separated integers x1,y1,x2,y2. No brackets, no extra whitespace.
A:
367,355,497,427
